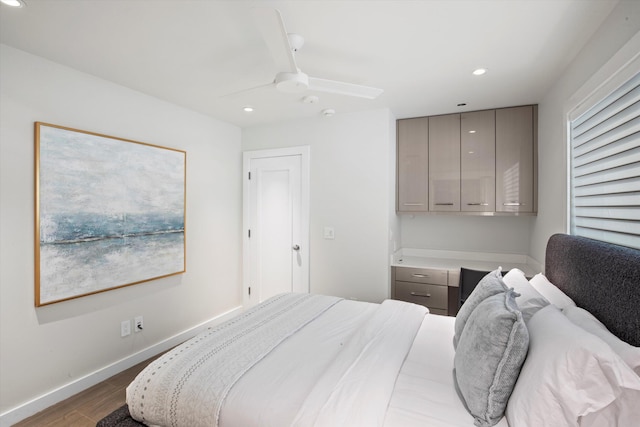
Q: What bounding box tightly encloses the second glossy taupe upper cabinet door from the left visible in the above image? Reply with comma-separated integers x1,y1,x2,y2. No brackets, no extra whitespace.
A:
429,114,460,212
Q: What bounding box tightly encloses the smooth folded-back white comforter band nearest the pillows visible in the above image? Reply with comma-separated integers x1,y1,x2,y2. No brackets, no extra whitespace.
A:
293,300,427,427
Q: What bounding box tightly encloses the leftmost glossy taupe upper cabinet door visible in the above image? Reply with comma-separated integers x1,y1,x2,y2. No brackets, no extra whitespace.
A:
396,117,429,212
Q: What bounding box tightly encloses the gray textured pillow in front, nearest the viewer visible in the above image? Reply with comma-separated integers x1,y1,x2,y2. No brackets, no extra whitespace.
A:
454,289,529,427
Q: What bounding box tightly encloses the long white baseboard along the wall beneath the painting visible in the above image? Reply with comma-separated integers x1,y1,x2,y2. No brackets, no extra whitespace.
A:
0,306,242,427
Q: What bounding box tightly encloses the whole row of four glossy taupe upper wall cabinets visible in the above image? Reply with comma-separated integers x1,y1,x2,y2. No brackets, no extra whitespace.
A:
396,105,538,215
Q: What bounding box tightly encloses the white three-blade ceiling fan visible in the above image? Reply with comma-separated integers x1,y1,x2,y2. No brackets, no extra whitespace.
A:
235,7,383,99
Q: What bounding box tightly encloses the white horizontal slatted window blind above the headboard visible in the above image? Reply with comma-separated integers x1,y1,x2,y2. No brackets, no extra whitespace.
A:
570,73,640,249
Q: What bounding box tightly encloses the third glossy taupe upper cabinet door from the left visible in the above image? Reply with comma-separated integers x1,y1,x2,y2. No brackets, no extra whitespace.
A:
460,110,496,212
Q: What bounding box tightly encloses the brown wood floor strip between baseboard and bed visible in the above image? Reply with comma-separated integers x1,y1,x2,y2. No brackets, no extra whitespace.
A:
14,356,159,427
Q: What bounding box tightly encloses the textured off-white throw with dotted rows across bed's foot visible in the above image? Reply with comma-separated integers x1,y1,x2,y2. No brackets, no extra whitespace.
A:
127,294,340,427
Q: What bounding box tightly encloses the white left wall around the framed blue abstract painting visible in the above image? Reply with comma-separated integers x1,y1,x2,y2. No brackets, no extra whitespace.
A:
0,46,242,422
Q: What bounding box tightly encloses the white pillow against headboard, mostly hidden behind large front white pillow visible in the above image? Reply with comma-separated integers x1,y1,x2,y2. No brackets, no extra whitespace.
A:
562,306,640,375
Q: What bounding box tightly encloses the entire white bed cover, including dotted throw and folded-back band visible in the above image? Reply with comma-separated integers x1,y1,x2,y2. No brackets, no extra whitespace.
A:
127,294,427,427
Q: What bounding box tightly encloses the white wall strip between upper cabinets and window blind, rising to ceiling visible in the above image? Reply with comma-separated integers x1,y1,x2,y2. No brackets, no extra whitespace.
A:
529,0,640,262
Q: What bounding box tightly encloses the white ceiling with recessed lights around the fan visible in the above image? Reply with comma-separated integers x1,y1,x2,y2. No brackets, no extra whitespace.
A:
0,0,617,127
